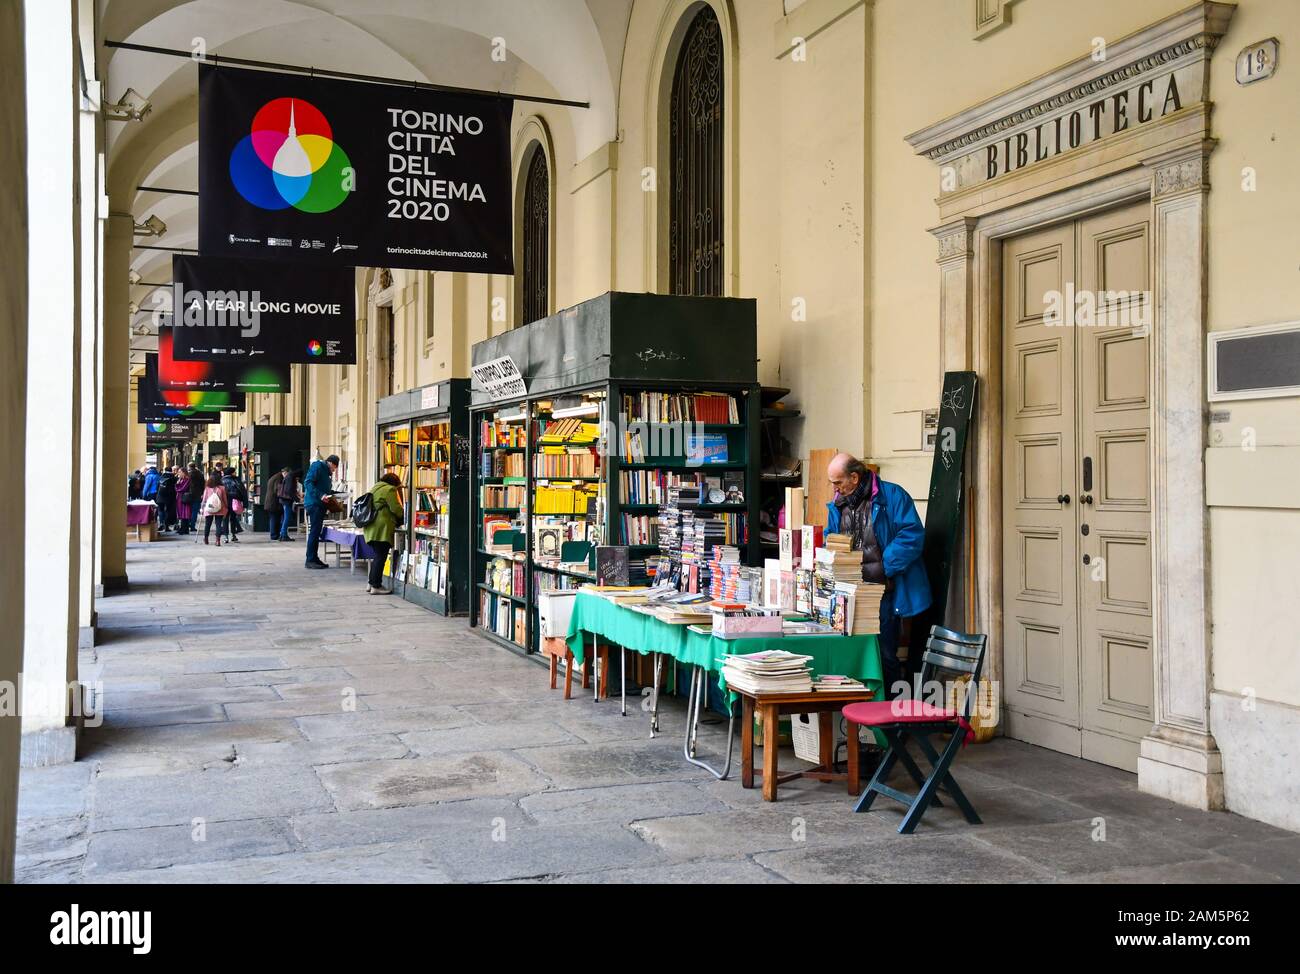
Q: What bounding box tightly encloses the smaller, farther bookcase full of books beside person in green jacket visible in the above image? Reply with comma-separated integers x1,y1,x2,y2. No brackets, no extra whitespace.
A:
378,378,469,615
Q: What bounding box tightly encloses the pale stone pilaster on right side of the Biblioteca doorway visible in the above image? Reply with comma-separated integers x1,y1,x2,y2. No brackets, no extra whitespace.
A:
1138,140,1223,809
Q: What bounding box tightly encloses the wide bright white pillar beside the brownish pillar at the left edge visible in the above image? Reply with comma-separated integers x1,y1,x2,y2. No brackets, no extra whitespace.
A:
21,4,83,766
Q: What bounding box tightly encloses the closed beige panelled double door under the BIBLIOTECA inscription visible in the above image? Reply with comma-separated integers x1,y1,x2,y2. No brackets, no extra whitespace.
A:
1002,203,1154,771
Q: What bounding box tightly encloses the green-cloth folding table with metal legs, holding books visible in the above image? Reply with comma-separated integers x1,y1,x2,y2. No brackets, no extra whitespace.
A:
567,590,884,778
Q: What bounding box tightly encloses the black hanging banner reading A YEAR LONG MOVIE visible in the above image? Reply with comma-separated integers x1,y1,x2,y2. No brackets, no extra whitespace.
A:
172,255,356,364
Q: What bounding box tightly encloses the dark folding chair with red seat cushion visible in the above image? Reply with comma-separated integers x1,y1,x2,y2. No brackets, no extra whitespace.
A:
844,625,988,835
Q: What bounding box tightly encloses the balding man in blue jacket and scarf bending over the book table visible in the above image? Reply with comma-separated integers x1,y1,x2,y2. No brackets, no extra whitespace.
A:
826,453,931,697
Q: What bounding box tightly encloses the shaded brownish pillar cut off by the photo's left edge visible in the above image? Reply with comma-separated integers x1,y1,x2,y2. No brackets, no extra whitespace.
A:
0,3,27,883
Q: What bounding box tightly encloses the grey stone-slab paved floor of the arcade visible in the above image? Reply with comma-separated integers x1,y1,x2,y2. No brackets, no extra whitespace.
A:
18,536,1300,883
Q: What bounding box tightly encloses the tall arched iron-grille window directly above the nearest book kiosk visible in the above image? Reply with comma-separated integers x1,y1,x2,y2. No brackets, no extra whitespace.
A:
668,5,723,295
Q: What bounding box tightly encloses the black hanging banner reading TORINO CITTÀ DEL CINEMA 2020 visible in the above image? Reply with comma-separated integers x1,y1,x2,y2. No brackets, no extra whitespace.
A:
199,65,514,274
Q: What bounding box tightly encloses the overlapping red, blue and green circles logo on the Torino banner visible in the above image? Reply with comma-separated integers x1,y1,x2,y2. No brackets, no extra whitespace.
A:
230,98,355,213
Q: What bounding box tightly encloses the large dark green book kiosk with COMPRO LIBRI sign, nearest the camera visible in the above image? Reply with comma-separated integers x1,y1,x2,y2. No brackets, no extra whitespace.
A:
469,293,762,652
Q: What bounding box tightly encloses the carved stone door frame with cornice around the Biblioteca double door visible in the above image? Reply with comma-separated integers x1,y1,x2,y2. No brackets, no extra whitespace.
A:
909,1,1232,809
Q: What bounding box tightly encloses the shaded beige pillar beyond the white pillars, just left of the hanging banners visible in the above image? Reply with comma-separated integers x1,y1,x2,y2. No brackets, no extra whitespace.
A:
96,205,135,594
